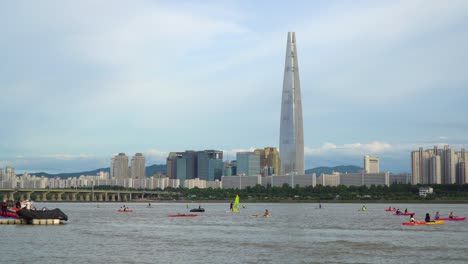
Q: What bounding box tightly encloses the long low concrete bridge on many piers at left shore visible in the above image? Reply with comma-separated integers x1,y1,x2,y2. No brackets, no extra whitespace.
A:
0,188,163,202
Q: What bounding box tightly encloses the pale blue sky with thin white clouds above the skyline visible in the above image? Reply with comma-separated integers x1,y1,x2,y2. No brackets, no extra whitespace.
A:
0,0,468,173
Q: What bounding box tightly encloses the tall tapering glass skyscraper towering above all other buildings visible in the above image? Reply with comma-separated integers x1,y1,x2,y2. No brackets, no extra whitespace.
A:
279,32,304,174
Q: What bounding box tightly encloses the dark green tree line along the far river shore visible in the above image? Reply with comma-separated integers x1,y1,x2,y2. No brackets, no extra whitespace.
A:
3,184,468,203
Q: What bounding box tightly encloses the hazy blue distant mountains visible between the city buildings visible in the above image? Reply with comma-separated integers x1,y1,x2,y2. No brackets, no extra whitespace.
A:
22,164,362,179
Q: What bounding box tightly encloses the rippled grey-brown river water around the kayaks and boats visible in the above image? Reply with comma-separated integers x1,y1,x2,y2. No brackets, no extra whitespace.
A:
0,203,468,263
